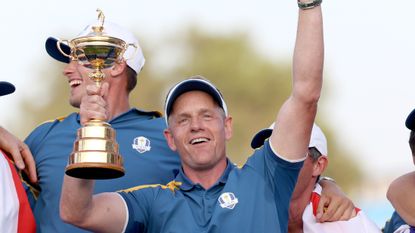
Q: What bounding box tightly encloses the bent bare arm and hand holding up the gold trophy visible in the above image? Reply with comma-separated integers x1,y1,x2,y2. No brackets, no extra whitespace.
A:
60,84,127,232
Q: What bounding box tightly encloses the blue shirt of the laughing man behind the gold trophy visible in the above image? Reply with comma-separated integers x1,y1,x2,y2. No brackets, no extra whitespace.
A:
25,109,180,233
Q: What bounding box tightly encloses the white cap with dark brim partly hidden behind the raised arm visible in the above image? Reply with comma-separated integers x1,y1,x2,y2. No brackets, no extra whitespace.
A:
251,123,327,156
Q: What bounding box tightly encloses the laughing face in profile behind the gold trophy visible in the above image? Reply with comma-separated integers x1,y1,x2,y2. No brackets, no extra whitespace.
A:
63,61,93,108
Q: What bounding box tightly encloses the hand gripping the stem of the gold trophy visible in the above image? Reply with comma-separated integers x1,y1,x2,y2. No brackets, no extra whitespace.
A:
79,82,109,125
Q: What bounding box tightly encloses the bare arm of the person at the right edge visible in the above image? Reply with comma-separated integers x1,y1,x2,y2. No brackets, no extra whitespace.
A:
386,172,415,226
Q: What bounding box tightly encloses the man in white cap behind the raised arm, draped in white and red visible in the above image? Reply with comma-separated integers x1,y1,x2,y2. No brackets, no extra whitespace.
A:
251,124,380,233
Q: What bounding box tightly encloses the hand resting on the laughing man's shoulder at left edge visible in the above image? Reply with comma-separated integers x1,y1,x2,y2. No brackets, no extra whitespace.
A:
0,127,37,183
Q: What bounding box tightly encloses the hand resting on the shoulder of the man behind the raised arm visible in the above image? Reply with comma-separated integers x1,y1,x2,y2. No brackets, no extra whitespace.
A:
316,180,356,222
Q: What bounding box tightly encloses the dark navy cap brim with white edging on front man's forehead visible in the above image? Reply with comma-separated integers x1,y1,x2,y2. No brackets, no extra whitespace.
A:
165,79,228,118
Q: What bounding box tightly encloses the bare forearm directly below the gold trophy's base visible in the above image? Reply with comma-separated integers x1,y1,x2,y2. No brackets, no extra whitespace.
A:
60,175,94,226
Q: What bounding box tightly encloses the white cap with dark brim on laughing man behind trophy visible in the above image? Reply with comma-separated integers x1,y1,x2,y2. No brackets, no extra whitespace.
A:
45,21,145,74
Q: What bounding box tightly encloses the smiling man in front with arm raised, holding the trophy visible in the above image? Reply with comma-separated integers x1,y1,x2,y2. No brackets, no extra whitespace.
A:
60,0,324,233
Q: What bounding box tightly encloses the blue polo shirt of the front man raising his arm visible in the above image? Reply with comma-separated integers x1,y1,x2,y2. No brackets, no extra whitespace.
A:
120,142,303,233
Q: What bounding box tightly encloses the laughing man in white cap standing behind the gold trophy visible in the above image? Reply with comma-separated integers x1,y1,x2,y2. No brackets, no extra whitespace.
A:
0,18,180,233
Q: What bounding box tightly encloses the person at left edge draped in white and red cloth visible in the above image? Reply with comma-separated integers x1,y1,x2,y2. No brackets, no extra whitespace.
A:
0,81,36,233
